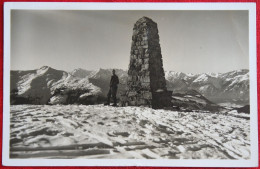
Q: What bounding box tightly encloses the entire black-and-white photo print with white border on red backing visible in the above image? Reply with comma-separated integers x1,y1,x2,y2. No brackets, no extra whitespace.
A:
3,3,258,167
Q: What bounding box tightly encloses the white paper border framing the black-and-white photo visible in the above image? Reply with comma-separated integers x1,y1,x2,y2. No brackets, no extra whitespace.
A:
2,2,258,167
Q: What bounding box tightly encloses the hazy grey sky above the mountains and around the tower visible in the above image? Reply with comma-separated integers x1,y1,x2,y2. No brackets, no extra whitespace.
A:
11,10,249,73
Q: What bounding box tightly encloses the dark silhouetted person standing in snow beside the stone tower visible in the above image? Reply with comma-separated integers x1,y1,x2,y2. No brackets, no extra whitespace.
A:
105,69,119,106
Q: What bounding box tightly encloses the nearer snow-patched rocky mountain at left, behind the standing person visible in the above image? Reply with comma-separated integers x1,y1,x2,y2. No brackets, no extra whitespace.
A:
11,66,100,104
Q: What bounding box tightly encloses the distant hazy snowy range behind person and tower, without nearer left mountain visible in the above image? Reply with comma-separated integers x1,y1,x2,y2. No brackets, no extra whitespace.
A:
71,69,249,105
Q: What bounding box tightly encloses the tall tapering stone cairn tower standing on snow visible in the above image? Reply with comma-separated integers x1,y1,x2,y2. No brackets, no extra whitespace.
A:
122,17,172,109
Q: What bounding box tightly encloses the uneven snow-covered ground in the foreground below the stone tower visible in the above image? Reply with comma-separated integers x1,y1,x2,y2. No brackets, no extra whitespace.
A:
10,105,250,159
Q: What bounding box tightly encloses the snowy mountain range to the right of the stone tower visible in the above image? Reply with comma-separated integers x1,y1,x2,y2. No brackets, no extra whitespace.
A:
165,69,249,104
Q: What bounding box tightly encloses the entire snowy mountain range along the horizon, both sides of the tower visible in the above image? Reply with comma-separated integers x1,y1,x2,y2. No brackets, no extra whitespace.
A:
11,66,249,105
